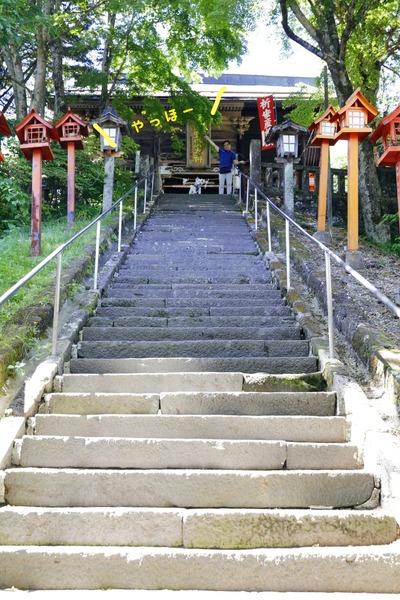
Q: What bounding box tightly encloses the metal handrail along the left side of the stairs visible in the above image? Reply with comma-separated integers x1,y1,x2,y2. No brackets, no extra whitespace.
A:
0,171,155,354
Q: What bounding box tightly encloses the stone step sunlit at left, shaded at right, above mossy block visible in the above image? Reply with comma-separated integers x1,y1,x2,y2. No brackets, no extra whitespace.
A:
69,356,322,376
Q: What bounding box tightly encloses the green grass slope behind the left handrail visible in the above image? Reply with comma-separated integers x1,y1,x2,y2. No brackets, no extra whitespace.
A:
0,218,114,338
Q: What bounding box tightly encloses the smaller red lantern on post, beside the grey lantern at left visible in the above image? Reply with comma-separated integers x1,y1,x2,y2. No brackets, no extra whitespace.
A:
55,108,88,225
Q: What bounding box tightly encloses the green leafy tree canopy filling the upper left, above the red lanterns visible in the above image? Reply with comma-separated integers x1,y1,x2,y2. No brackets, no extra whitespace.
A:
0,0,257,119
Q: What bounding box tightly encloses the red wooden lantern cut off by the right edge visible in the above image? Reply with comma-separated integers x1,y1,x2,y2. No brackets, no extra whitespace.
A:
370,104,400,232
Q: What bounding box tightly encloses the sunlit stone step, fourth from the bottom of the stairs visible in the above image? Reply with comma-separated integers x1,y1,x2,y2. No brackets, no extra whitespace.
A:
14,435,362,471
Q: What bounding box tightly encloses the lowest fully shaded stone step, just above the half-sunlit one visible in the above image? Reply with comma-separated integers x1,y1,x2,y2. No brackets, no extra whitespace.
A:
77,339,310,359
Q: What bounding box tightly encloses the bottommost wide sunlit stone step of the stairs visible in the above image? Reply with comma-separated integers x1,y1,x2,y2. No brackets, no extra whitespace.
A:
0,541,400,595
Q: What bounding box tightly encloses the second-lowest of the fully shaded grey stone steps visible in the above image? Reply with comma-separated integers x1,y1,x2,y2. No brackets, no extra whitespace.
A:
82,325,301,342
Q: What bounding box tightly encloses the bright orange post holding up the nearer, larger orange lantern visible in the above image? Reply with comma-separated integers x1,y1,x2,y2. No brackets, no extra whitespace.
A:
347,133,358,252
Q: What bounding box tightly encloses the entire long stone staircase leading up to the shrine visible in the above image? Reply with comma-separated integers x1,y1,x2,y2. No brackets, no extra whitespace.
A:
0,195,400,593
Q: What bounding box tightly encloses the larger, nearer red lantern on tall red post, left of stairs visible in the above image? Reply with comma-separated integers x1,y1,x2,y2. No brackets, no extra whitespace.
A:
15,109,58,256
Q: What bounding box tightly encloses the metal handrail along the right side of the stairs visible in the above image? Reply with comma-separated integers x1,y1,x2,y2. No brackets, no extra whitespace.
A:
239,171,400,358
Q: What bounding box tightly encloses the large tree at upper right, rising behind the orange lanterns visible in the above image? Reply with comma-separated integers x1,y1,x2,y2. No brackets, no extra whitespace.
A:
275,0,400,241
